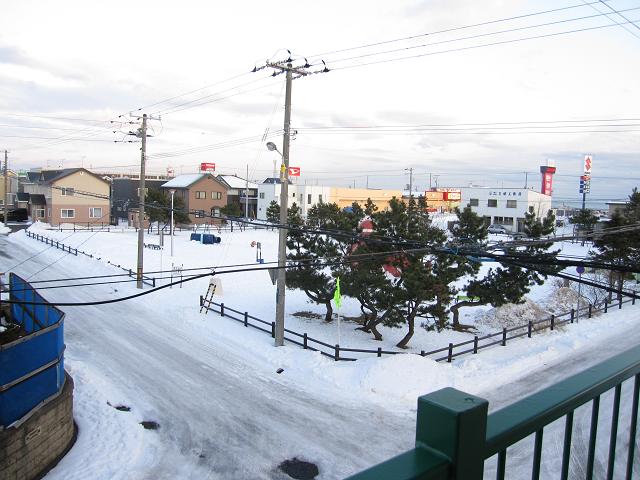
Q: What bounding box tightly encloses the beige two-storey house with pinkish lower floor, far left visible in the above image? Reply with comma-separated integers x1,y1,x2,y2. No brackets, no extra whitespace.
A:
23,168,110,225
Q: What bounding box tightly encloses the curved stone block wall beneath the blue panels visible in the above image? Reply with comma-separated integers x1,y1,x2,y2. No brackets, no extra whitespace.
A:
0,375,75,480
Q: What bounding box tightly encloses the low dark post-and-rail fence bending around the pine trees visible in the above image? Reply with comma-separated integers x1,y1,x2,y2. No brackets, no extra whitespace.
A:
200,295,636,363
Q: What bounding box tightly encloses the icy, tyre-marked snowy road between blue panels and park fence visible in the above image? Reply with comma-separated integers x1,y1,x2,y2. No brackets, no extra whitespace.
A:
0,238,415,480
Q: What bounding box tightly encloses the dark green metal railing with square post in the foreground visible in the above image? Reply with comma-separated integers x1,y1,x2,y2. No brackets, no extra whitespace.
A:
349,347,640,480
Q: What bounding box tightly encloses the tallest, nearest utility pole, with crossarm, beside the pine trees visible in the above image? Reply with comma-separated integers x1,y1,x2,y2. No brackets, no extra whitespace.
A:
262,58,320,347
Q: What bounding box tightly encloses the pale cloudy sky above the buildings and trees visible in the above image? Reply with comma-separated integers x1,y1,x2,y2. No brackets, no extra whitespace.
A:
0,0,640,206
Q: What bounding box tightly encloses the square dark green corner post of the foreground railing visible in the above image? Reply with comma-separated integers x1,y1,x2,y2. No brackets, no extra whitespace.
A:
416,388,489,480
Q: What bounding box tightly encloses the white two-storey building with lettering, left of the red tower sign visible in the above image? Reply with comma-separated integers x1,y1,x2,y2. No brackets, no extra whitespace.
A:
461,187,551,232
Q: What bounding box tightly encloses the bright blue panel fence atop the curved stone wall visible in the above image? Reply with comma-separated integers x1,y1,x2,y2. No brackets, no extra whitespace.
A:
0,273,65,429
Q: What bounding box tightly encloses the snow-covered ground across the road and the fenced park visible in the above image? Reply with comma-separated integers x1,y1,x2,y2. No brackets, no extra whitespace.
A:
0,225,640,480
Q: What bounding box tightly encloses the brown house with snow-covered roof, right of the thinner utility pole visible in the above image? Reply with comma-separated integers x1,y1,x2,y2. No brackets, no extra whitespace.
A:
162,173,227,225
